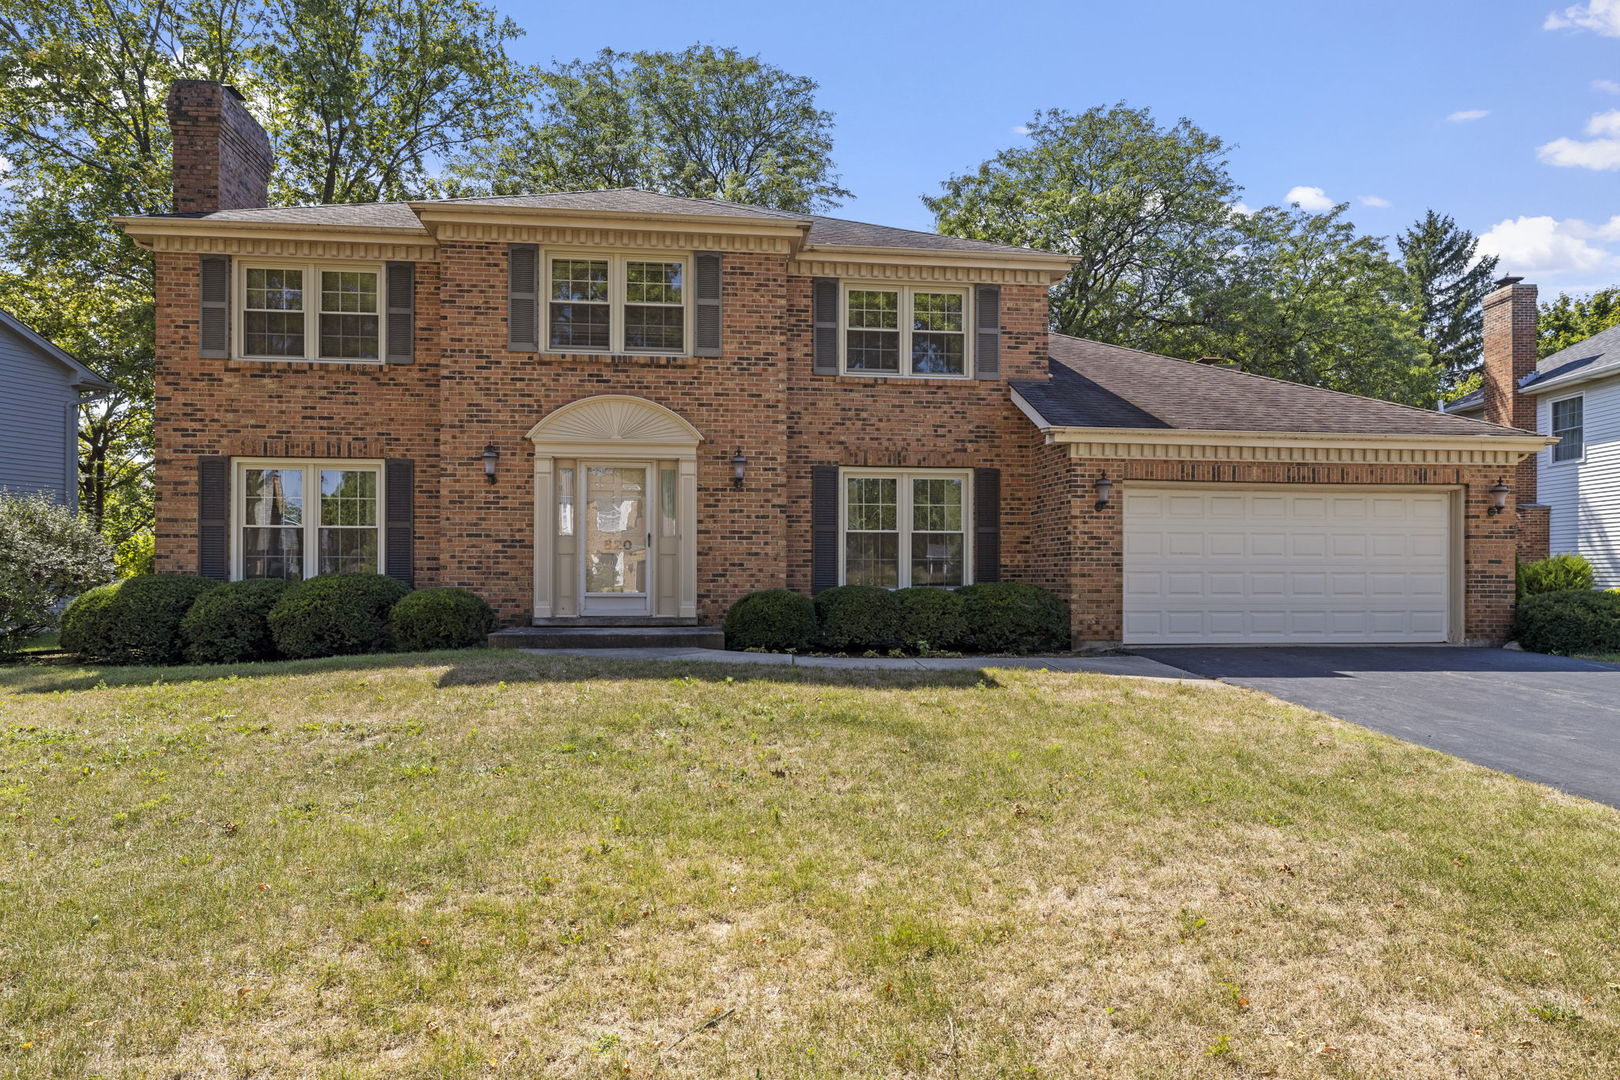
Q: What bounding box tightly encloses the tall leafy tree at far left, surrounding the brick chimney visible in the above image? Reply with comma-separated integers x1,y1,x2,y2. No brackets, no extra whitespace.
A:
0,0,525,539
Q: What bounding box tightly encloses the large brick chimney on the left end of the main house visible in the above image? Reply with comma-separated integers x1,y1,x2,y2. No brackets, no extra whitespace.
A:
168,79,271,214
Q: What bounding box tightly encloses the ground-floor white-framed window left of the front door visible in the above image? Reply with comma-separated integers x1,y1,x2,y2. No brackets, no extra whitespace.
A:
232,460,382,581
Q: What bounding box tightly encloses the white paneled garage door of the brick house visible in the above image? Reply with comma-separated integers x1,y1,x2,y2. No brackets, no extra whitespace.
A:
1124,487,1452,644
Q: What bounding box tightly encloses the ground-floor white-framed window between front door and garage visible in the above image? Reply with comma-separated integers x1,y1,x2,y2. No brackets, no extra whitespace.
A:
839,470,972,589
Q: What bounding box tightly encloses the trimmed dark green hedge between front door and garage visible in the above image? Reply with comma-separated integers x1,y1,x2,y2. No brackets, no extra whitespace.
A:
726,581,1069,653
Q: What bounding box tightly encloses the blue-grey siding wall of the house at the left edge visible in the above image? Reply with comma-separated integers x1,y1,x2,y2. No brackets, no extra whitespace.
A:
0,325,78,502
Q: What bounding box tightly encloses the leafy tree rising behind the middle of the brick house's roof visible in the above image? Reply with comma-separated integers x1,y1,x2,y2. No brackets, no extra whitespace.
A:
446,45,851,212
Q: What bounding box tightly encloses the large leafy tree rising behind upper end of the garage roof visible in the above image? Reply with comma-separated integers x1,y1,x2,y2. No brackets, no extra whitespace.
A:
923,102,1239,348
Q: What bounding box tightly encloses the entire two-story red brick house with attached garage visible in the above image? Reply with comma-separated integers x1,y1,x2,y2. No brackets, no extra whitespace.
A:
110,83,1545,644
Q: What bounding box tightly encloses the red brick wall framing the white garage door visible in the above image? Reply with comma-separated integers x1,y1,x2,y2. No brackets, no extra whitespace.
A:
1037,449,1518,644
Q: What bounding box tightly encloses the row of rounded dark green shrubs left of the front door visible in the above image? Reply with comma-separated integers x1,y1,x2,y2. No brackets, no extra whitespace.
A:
62,573,496,664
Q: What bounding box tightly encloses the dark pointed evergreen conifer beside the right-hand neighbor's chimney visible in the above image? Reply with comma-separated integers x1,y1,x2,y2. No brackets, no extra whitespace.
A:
1395,210,1497,385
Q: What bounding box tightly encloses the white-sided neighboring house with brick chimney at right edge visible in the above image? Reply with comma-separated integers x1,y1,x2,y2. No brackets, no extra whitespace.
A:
1445,277,1620,588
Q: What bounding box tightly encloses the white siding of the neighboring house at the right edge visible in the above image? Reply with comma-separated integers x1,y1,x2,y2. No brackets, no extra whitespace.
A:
1536,377,1620,589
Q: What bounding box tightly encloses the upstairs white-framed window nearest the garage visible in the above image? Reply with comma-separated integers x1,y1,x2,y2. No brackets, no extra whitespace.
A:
839,282,972,379
